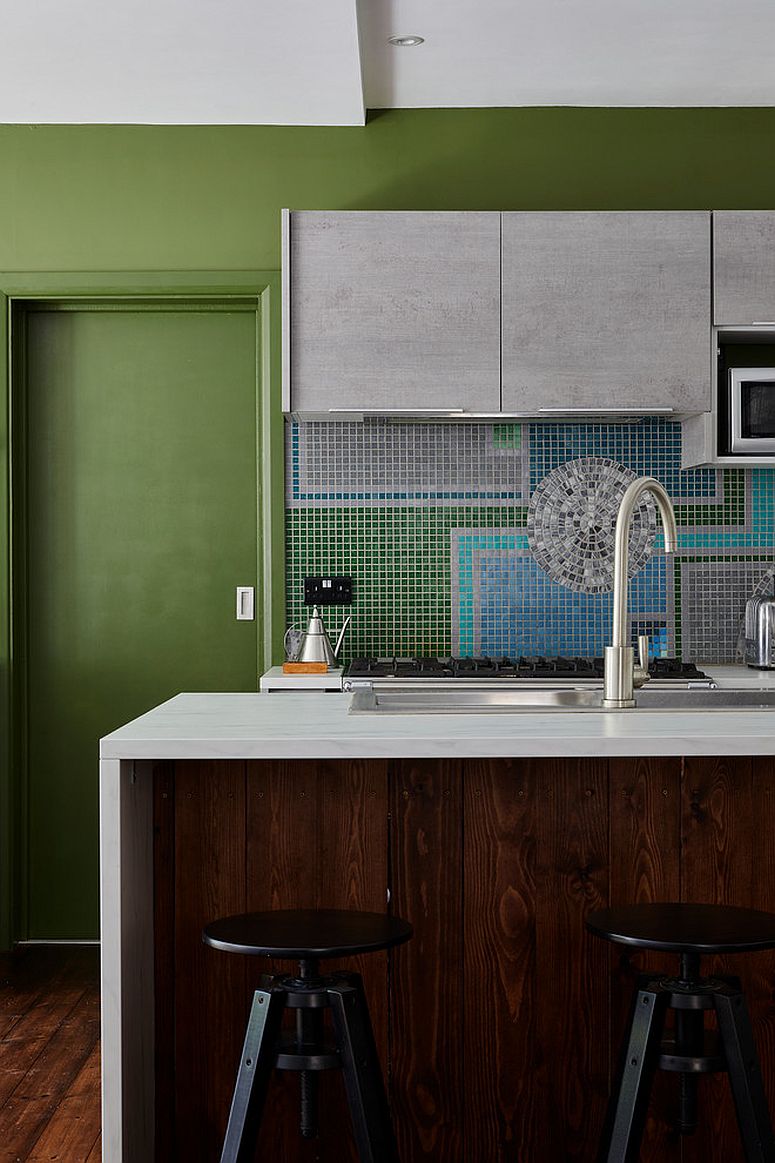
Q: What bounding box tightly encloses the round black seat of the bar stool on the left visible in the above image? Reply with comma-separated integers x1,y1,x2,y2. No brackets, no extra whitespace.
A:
202,908,412,959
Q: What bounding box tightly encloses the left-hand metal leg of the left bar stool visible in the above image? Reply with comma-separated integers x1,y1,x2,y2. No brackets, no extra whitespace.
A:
221,989,285,1163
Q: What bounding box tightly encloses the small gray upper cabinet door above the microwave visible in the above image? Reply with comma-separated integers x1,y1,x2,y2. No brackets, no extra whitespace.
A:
713,211,775,327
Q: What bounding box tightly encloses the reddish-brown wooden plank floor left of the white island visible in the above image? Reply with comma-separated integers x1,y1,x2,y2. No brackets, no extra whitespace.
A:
0,946,100,1163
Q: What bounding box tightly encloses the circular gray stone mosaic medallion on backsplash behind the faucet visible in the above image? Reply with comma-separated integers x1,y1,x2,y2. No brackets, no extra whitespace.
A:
527,456,656,593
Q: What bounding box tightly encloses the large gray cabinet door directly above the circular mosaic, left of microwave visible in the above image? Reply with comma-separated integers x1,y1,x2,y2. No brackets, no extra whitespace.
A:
503,212,711,415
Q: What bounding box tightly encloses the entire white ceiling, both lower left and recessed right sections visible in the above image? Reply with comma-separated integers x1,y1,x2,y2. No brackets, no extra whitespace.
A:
0,0,775,126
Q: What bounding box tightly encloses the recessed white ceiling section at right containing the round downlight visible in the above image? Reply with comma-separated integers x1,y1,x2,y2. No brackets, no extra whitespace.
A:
362,0,775,108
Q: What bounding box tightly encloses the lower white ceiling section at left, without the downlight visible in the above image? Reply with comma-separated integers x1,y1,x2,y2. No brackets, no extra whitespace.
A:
0,0,364,126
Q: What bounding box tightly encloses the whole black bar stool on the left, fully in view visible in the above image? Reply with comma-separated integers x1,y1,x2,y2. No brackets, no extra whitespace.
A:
202,908,412,1163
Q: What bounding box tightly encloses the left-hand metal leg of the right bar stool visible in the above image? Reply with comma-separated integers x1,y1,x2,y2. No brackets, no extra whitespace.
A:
598,977,670,1163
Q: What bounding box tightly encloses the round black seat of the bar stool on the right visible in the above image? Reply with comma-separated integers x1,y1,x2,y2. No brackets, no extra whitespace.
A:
586,902,775,954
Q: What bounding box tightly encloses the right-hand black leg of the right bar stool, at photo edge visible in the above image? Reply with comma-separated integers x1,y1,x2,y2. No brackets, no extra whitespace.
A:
714,985,775,1163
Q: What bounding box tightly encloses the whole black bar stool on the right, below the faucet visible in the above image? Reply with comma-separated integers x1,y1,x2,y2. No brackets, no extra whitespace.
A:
586,904,775,1163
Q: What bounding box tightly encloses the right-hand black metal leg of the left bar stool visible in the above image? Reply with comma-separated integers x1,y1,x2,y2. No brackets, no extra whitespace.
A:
328,973,398,1163
